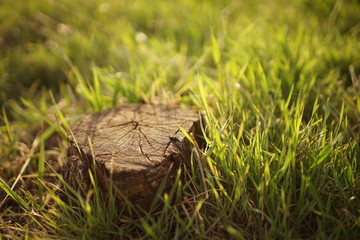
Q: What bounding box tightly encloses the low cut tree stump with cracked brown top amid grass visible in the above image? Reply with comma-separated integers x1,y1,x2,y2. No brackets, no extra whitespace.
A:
64,104,201,208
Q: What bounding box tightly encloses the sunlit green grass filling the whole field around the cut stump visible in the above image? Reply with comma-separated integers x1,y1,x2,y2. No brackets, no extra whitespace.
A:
0,0,360,239
